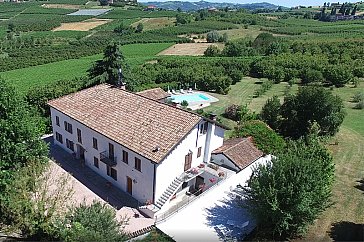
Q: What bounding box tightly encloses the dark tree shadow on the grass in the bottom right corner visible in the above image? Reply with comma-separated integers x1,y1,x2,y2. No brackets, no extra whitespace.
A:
329,221,364,241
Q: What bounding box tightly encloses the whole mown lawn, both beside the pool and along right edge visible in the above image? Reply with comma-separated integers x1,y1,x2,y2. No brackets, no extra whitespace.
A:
205,77,364,241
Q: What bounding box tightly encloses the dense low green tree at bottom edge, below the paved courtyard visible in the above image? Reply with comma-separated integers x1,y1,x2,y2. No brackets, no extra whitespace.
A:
60,201,127,242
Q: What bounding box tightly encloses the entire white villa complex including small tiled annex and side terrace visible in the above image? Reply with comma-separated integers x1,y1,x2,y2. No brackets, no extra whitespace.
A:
48,84,270,238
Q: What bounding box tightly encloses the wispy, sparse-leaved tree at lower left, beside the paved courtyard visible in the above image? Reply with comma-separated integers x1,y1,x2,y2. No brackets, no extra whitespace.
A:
0,162,73,240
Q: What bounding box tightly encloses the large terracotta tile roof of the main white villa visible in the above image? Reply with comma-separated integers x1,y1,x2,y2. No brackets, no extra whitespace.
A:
48,84,202,163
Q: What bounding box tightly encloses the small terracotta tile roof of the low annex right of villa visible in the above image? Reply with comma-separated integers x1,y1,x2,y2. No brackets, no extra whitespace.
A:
212,137,263,169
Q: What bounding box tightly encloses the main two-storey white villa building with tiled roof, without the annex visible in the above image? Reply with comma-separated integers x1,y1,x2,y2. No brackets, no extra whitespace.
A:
49,85,225,207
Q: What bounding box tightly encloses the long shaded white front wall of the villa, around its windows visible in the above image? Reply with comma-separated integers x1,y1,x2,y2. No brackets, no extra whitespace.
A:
51,108,154,203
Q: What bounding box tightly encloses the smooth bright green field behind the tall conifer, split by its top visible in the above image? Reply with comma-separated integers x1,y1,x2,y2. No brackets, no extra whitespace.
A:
0,43,173,94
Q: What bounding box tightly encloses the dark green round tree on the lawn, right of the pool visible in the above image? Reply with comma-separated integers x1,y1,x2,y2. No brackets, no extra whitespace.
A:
280,86,345,139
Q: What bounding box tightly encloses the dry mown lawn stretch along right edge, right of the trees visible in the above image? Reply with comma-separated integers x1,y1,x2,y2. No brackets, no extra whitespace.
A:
302,82,364,241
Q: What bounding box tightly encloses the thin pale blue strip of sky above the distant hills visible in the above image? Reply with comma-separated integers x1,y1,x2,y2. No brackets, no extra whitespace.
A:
140,0,358,7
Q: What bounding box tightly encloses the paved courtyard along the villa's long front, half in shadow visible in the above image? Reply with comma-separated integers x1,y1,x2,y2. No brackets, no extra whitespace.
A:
44,136,154,233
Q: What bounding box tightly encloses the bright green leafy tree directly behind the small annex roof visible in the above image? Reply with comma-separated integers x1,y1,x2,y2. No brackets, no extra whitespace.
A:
233,120,286,154
